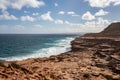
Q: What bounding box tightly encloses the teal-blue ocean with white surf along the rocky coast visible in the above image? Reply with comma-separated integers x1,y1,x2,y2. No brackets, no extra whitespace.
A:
0,34,77,61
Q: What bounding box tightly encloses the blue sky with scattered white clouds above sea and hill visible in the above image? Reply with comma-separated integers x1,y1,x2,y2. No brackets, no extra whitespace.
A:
0,0,120,34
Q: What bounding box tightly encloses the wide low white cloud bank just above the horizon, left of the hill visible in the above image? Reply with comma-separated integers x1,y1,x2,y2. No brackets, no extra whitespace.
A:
65,17,110,32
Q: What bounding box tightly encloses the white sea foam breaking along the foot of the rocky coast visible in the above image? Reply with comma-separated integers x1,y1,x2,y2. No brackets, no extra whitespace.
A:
0,37,74,61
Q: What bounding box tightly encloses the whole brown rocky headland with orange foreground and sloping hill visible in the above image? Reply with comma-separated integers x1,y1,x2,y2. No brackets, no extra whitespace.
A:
0,22,120,80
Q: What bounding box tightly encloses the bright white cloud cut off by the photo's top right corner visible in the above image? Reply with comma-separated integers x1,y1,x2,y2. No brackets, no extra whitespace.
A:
85,0,120,8
